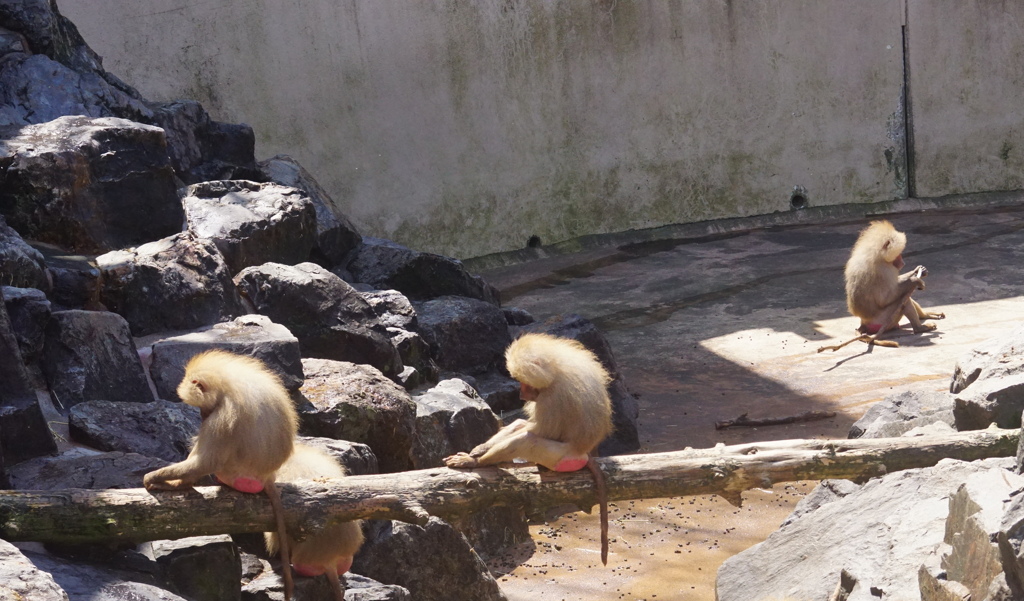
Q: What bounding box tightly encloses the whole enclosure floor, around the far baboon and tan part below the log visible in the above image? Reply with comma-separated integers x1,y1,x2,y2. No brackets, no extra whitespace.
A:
480,197,1024,600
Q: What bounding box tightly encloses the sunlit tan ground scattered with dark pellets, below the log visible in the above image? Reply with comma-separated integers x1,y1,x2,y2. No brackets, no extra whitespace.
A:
488,482,815,601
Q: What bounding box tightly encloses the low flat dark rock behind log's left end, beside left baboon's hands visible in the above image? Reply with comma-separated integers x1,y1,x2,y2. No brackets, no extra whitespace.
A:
10,448,170,490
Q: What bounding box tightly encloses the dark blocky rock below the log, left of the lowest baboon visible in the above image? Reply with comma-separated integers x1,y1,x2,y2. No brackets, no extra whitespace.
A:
143,534,242,601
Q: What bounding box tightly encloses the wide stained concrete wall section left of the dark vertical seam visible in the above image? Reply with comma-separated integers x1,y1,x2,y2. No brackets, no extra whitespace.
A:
60,0,913,257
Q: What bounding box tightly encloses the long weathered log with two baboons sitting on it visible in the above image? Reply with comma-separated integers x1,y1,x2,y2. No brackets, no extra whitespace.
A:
0,428,1007,544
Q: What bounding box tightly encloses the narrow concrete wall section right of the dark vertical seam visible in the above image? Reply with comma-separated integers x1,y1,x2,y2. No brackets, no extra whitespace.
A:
907,0,1024,197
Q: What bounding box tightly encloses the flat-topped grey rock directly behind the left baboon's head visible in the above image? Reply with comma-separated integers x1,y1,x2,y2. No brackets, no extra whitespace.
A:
144,315,305,400
